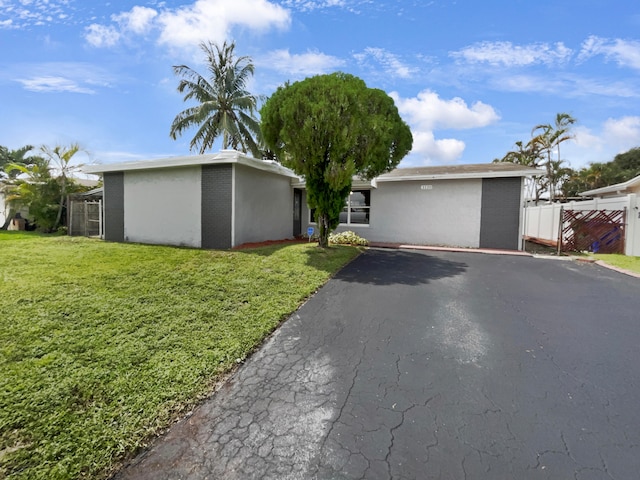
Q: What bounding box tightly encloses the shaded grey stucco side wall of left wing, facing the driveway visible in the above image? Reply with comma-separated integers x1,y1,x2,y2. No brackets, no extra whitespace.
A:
233,164,292,246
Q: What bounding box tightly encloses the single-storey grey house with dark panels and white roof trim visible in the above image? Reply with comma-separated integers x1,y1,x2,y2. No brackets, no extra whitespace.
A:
85,150,540,249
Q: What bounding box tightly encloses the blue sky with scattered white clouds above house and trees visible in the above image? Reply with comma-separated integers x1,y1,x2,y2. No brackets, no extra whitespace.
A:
0,0,640,168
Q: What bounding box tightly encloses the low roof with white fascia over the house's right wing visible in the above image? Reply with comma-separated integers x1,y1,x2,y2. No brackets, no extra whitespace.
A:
376,162,544,182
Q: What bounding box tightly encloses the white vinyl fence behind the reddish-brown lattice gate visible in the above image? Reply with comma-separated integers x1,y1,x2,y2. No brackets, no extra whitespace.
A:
524,194,640,256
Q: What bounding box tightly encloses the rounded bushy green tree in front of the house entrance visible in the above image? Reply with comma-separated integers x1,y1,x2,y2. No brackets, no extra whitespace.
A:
260,72,413,247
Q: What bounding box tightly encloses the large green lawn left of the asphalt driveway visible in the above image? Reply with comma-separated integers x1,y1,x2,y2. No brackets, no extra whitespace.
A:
0,232,358,479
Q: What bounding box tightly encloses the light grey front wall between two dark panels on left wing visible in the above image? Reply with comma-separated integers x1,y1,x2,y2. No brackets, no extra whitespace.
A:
124,167,201,247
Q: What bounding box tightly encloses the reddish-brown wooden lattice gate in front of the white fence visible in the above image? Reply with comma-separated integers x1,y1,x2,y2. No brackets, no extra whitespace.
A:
558,209,626,253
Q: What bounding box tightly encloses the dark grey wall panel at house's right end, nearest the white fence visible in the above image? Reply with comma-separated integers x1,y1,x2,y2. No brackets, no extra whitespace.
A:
480,178,522,250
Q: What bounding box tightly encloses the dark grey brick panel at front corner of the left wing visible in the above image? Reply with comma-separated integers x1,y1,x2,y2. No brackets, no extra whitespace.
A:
202,164,233,248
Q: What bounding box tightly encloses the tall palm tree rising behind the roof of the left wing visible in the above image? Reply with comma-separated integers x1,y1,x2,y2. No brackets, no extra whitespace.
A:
169,41,261,156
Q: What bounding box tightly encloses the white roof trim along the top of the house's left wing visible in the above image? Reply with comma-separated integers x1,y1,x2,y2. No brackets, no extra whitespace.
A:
82,150,298,178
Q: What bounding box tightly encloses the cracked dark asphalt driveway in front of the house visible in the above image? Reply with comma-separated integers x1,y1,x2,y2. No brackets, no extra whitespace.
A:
115,249,640,480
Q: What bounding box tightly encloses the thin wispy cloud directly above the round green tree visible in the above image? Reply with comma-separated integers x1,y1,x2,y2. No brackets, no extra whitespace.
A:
257,50,344,77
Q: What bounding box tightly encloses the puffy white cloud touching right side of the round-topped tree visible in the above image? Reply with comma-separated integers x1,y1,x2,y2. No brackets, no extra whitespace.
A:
390,90,500,164
